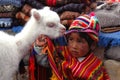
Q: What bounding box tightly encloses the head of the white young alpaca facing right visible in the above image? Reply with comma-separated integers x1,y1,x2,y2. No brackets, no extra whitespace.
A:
31,7,66,38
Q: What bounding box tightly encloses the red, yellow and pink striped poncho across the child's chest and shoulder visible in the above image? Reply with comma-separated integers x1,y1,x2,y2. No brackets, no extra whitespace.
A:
62,53,110,80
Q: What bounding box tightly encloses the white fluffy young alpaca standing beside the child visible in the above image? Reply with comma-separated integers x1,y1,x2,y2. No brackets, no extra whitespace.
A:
0,7,65,80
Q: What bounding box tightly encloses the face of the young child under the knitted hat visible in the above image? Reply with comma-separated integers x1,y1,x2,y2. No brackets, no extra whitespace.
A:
68,33,90,58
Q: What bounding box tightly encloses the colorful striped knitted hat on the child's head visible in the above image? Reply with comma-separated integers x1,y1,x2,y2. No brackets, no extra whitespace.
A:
66,14,100,42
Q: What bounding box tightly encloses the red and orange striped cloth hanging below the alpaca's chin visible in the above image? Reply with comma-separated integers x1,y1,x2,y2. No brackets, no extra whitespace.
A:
44,37,68,80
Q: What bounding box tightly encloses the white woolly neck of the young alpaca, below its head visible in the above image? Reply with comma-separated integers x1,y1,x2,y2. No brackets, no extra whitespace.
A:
15,19,40,55
